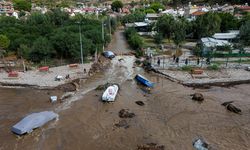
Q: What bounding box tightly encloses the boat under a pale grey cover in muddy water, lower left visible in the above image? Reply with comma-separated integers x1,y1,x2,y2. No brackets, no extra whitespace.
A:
11,111,58,135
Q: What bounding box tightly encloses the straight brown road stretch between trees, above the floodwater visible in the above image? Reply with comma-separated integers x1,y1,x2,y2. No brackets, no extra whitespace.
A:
108,29,130,54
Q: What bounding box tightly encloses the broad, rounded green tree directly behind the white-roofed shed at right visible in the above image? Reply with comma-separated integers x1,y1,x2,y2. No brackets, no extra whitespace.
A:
194,12,221,38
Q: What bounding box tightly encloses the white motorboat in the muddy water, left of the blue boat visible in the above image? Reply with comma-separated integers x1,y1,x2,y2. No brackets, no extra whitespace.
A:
102,85,119,102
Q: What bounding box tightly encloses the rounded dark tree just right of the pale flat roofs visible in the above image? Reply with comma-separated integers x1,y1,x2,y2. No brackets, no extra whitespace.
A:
156,15,175,39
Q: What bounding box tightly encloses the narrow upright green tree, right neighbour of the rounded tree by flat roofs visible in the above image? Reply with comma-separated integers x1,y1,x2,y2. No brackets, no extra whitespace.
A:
172,20,186,48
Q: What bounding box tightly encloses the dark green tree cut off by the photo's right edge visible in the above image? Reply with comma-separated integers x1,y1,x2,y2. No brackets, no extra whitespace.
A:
239,20,250,46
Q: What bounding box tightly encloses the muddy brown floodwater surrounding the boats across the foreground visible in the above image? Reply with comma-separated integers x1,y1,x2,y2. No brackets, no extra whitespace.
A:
0,31,250,150
